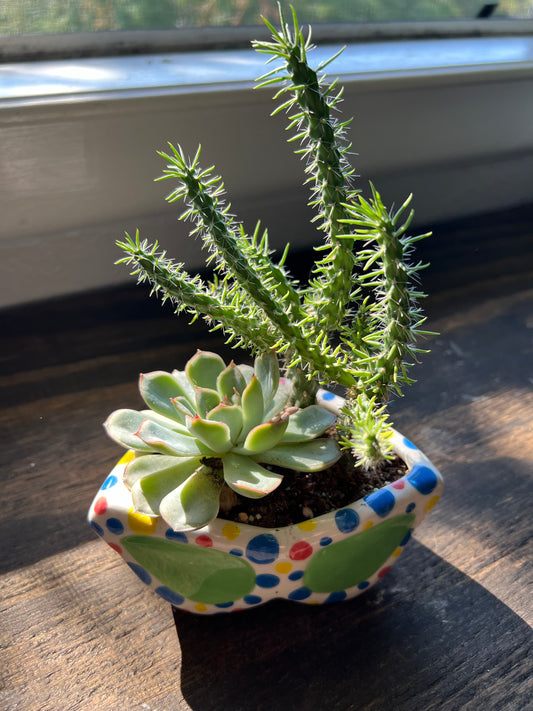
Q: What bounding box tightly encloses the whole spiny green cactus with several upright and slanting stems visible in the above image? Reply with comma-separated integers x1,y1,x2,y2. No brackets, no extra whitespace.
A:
119,12,432,468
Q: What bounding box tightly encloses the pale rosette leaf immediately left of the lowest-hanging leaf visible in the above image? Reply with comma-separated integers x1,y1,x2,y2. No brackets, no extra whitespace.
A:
130,457,200,516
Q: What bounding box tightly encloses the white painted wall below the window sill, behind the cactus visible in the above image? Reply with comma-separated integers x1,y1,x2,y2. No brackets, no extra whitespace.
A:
0,38,533,306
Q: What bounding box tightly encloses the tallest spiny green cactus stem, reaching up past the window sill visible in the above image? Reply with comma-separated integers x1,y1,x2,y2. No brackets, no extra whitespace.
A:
253,9,356,333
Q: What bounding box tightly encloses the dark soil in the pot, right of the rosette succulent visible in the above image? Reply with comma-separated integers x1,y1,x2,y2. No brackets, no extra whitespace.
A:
219,454,407,528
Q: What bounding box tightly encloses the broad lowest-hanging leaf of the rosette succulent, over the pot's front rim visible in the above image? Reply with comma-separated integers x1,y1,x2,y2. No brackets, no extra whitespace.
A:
159,464,223,531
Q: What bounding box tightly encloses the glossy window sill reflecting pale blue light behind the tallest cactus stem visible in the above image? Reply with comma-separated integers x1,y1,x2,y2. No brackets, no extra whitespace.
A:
0,37,533,108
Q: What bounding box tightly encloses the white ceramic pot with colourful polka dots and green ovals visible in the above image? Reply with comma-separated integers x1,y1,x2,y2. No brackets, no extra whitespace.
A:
89,391,443,614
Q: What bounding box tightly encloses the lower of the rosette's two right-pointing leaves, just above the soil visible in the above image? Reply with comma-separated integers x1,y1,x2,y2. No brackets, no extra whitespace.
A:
254,439,341,472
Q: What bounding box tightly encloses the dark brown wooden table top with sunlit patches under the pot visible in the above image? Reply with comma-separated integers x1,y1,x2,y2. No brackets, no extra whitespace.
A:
0,208,533,711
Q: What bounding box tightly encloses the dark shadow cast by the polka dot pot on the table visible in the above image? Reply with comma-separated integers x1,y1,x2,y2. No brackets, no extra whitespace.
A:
175,541,531,711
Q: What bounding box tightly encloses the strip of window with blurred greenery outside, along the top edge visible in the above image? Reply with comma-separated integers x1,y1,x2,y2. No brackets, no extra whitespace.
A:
0,0,533,35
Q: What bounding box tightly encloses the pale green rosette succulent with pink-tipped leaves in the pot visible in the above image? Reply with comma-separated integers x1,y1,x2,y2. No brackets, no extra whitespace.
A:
105,351,340,531
